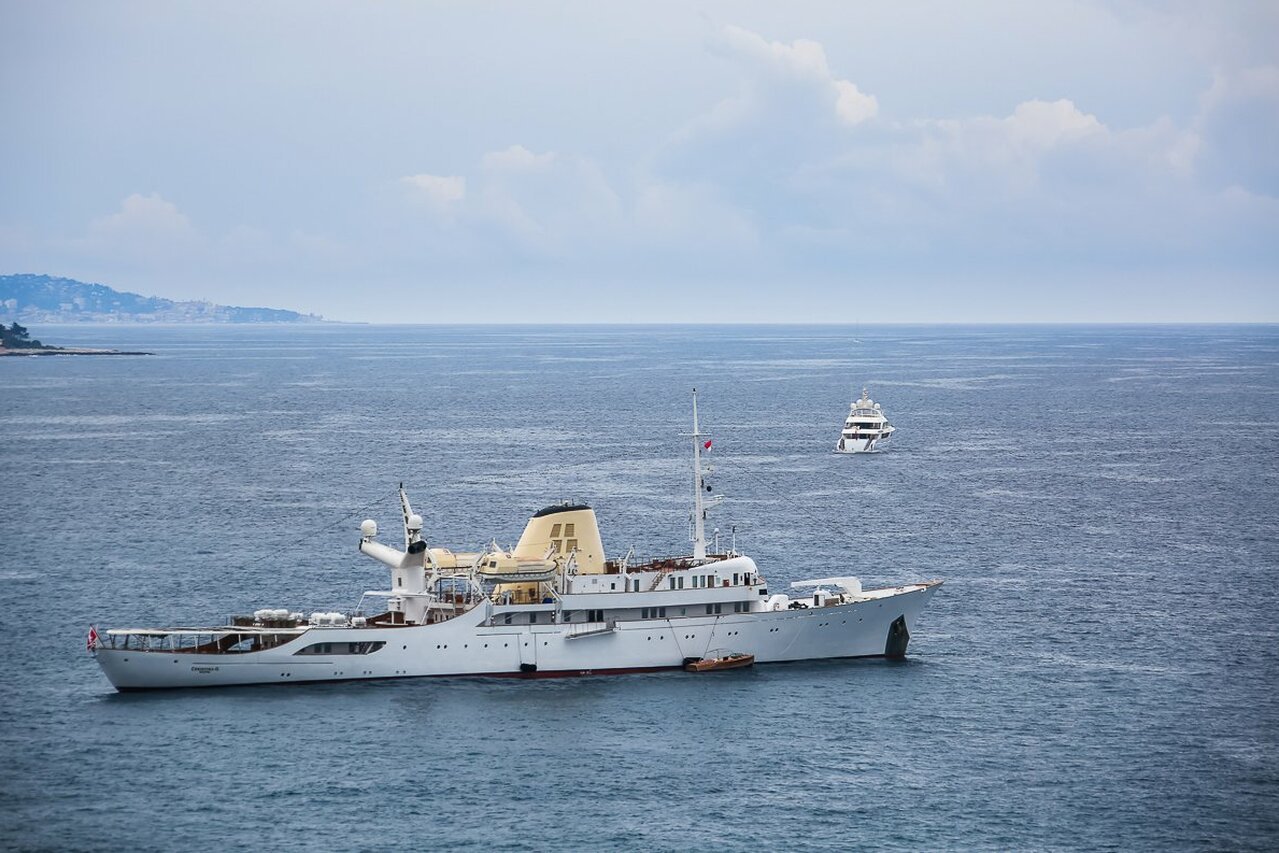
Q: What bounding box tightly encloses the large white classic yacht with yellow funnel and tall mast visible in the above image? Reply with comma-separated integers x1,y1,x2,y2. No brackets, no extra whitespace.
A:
88,391,941,691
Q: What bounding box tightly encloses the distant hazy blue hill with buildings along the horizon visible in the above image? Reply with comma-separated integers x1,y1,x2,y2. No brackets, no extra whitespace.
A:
0,274,322,322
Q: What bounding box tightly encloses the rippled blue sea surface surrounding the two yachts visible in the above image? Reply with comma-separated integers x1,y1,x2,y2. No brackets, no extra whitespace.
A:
0,326,1279,850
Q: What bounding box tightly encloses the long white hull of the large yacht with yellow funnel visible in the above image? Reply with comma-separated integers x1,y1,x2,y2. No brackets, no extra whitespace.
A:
96,584,938,691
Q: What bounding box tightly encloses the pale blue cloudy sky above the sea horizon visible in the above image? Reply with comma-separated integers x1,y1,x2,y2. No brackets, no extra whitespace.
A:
0,0,1279,324
